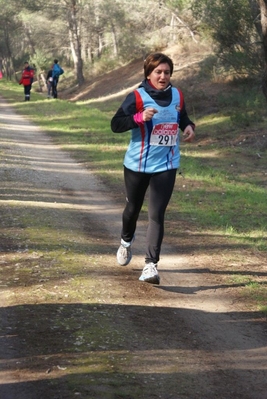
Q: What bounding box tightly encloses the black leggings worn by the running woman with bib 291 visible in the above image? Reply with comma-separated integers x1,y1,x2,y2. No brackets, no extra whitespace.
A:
121,167,176,263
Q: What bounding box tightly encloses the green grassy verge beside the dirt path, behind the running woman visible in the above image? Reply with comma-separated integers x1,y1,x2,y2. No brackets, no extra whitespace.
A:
1,77,267,311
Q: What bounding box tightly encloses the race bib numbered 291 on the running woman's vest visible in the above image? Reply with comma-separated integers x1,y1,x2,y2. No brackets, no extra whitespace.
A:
150,123,179,147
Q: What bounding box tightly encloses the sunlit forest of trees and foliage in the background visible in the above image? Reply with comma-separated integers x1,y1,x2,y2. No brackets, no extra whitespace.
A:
0,0,267,100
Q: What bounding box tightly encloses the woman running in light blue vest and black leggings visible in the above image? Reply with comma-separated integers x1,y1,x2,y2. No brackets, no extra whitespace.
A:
111,53,195,284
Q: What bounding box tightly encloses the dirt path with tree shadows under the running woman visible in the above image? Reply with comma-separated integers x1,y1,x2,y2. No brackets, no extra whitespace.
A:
0,99,267,399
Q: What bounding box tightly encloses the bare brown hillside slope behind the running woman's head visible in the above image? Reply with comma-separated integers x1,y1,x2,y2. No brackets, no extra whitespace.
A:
61,45,217,113
